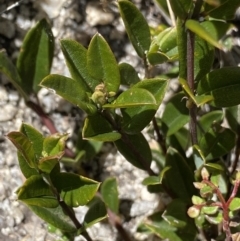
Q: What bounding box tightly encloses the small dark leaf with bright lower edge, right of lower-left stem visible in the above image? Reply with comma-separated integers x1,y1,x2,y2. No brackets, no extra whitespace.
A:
83,199,107,229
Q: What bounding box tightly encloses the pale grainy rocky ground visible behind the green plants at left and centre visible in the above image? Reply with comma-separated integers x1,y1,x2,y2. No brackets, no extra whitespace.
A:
0,0,168,241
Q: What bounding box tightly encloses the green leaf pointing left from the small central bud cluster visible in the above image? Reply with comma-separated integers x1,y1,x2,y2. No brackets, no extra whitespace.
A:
41,74,97,115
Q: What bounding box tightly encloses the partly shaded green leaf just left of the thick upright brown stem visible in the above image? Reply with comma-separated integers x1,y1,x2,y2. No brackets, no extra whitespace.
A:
161,93,189,136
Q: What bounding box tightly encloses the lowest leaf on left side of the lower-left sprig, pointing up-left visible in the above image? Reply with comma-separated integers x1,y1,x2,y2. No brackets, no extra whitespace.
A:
28,205,77,233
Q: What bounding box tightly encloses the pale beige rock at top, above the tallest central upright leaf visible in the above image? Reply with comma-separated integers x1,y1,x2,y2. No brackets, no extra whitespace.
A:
86,2,114,26
